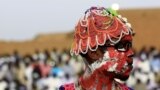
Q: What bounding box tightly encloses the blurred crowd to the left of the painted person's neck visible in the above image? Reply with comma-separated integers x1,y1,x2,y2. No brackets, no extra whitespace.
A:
0,49,83,90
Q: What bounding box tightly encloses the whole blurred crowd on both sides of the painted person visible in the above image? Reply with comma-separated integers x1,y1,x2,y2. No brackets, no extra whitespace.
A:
0,47,160,90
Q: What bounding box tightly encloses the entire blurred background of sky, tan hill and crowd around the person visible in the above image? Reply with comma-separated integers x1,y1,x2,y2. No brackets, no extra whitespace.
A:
0,0,160,90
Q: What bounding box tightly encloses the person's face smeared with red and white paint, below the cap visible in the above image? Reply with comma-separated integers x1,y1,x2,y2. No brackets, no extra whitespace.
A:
87,35,134,80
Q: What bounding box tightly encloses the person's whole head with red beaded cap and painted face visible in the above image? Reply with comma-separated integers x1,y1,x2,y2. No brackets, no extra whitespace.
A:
71,7,133,80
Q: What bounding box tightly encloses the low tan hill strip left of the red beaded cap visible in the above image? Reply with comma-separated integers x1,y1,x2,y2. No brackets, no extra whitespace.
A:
0,33,72,55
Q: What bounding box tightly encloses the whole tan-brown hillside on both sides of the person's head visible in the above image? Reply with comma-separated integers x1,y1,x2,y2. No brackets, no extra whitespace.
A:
0,9,160,55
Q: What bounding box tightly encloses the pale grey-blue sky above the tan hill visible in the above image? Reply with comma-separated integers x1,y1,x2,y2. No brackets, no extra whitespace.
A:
0,0,160,41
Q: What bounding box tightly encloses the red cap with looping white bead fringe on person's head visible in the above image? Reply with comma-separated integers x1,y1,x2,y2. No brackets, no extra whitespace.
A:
71,7,133,55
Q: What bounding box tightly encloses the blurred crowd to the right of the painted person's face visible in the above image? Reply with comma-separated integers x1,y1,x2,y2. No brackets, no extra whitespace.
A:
126,47,160,90
